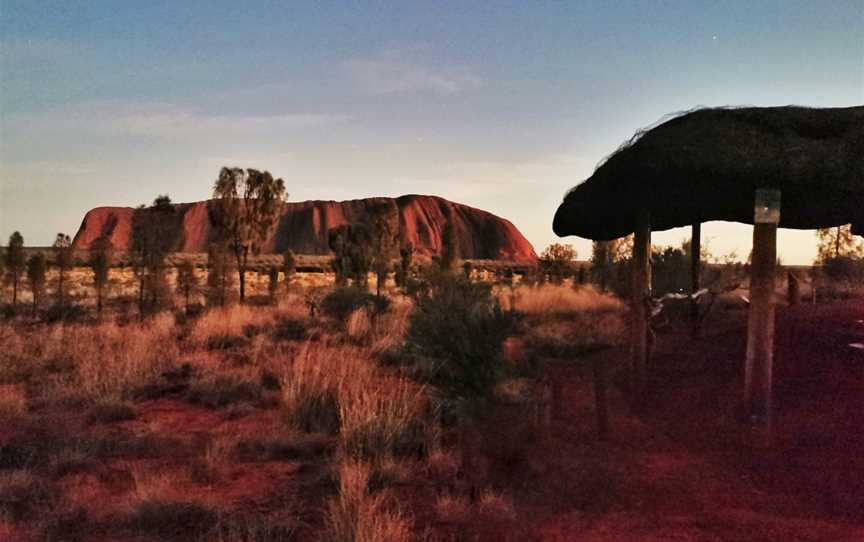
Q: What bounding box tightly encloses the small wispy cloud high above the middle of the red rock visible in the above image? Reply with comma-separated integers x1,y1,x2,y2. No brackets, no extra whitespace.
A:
342,48,483,95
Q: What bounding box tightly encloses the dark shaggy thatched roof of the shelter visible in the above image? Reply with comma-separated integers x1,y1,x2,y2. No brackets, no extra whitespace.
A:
552,106,864,240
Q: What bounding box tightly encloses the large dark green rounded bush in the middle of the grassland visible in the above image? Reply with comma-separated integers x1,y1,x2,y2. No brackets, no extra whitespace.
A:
406,274,512,398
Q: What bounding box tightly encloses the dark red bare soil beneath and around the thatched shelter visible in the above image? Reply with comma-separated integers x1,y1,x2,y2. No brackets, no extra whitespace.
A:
512,301,864,542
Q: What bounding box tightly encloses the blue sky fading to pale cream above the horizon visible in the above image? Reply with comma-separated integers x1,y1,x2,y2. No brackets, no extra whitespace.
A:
0,0,864,264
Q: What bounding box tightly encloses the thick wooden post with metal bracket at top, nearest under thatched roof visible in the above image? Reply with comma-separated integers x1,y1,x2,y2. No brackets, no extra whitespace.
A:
744,191,779,429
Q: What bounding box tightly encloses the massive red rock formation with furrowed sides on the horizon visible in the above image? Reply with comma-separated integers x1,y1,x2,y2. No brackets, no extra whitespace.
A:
74,195,537,262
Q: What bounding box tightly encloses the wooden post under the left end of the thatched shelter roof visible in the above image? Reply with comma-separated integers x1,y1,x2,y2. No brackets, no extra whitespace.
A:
630,209,651,402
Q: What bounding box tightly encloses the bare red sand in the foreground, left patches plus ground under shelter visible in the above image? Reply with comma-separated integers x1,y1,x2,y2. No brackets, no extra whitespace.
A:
6,301,864,542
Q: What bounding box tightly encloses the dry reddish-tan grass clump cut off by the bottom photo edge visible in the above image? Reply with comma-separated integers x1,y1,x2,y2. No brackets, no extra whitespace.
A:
326,462,411,542
